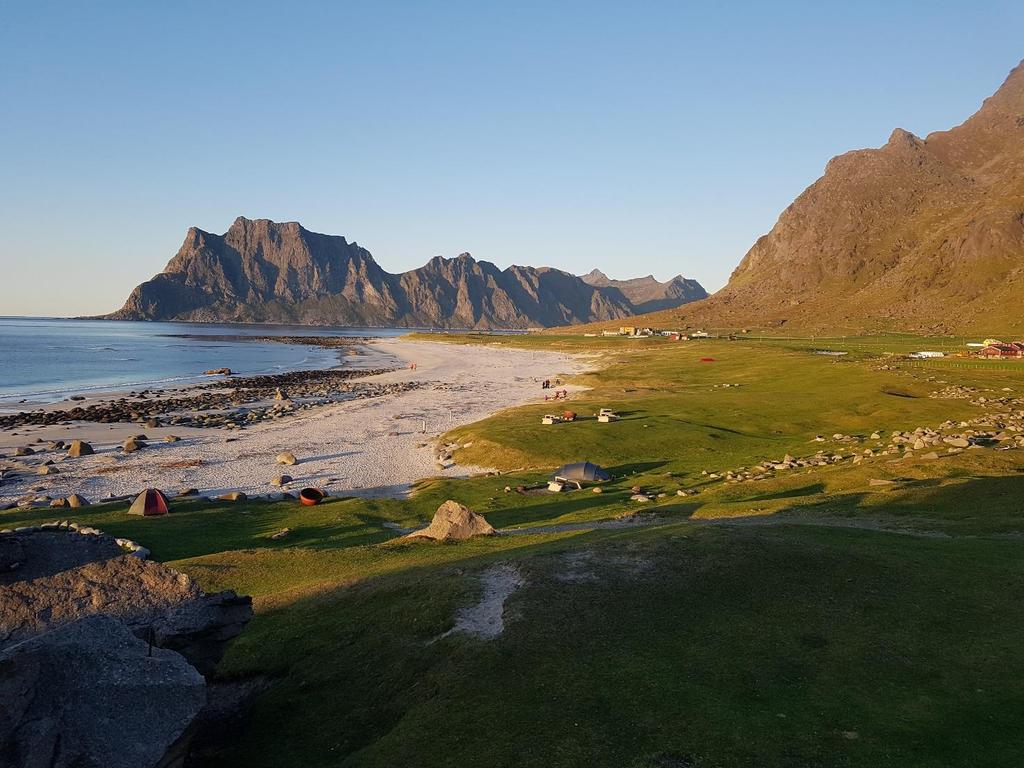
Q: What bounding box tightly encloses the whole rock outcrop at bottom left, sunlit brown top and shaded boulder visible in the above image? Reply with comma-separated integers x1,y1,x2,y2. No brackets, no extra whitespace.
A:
0,523,252,768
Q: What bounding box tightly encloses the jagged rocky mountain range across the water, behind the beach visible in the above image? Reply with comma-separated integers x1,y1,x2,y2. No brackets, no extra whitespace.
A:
104,217,707,329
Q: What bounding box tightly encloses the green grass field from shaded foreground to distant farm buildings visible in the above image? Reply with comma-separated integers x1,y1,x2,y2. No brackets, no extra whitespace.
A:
8,335,1024,768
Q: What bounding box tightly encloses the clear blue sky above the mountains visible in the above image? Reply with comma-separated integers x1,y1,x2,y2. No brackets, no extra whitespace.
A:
0,0,1024,314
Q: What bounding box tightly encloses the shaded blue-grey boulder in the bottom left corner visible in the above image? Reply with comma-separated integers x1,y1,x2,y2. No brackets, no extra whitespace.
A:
0,615,206,768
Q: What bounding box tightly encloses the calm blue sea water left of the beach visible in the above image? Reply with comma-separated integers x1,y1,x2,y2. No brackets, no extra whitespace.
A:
0,317,408,409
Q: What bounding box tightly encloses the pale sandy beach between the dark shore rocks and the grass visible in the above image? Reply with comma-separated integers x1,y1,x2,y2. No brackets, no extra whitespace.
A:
0,338,588,504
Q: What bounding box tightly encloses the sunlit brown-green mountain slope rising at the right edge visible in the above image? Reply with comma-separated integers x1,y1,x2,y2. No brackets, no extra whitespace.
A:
577,63,1024,332
